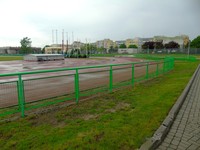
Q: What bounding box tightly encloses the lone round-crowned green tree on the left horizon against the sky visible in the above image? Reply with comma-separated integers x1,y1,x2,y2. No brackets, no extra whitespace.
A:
20,37,32,54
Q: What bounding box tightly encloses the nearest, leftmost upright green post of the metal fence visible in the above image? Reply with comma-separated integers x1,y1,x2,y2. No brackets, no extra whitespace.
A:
18,75,25,117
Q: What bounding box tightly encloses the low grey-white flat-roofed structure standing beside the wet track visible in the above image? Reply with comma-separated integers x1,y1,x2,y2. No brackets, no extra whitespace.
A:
24,54,65,61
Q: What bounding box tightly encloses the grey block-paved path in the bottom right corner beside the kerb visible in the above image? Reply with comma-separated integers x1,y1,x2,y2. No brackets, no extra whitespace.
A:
157,70,200,150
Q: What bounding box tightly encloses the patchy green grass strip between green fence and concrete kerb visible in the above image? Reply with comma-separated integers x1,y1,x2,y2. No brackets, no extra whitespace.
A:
0,62,199,150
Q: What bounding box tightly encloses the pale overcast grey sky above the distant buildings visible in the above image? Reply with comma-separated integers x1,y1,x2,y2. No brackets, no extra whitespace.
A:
0,0,200,47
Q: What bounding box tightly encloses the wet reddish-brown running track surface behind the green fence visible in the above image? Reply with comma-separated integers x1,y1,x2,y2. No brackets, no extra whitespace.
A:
0,57,162,108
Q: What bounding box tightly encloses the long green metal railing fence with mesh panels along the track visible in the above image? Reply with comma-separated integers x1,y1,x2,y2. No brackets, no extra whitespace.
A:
0,57,174,118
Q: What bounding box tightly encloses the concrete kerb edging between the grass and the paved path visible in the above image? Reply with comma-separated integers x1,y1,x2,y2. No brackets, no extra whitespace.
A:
139,65,200,150
